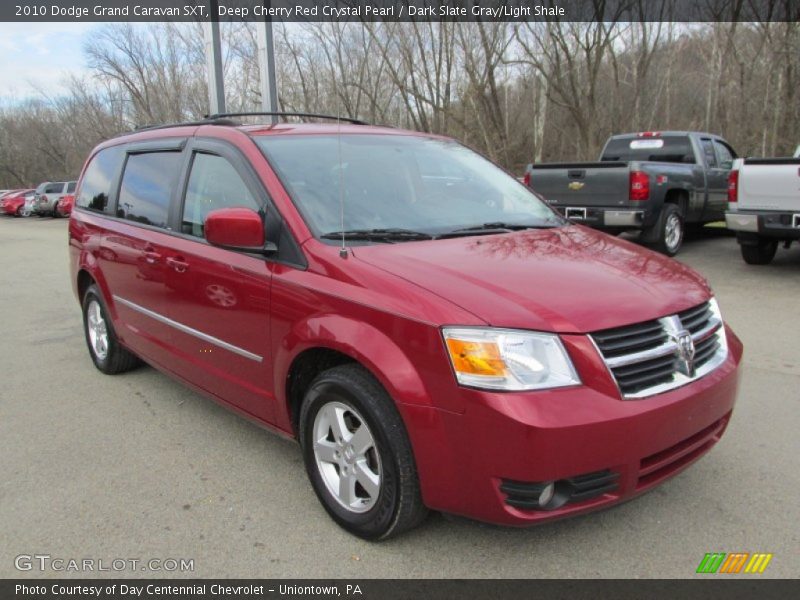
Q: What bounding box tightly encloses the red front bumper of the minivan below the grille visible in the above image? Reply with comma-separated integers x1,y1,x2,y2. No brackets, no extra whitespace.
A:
402,329,742,526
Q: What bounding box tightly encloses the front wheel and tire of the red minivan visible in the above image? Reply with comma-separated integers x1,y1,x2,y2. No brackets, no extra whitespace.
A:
299,365,427,540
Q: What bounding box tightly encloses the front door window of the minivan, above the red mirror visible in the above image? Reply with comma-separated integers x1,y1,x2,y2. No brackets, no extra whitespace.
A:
181,153,260,237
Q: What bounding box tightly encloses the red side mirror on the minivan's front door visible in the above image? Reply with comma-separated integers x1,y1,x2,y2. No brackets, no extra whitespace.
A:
204,208,277,254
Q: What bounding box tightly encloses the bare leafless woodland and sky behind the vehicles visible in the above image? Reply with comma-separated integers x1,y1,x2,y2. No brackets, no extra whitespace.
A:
0,11,800,188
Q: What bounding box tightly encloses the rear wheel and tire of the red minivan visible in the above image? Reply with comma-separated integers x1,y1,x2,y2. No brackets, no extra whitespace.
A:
83,285,141,375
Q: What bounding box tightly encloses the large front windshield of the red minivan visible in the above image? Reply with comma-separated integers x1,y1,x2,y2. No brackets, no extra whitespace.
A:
255,134,564,241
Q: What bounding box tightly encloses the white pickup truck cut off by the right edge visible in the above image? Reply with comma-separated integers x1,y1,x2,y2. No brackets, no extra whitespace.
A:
725,146,800,265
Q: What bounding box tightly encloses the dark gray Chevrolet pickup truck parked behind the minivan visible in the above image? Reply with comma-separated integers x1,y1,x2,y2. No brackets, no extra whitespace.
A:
524,131,736,256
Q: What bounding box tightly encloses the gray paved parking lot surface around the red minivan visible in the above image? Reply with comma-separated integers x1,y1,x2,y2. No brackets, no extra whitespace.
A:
0,218,800,578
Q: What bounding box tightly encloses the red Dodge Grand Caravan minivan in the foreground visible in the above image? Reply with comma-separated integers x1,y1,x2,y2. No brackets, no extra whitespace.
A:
69,115,742,539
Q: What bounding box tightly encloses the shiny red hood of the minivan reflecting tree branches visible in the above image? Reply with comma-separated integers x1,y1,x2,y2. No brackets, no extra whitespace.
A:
353,225,711,333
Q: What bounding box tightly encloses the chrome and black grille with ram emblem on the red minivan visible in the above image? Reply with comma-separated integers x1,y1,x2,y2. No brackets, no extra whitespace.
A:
591,299,728,399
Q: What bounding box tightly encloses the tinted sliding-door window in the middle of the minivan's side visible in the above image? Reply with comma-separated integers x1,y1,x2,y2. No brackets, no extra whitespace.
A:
117,152,181,227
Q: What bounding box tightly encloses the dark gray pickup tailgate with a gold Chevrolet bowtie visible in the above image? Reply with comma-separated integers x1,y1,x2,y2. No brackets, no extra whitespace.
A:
528,162,630,207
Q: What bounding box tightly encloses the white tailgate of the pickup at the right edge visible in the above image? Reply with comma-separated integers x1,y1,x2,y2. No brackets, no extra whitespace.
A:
739,158,800,211
